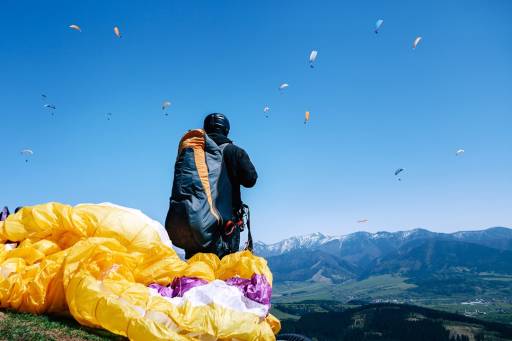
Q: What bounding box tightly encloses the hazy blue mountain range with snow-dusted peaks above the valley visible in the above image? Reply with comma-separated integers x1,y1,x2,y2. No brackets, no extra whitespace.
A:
254,227,512,283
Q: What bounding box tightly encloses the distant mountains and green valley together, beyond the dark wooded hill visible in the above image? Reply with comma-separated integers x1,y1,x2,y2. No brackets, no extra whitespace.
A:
258,228,512,324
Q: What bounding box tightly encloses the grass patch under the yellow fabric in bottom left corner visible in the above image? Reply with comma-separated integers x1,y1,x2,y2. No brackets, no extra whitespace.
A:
0,310,125,341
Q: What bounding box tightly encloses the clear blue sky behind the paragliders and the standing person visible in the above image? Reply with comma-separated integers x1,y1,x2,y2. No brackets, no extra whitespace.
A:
0,0,512,242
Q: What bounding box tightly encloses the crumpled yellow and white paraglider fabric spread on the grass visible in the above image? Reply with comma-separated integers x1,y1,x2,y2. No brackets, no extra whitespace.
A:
0,203,280,340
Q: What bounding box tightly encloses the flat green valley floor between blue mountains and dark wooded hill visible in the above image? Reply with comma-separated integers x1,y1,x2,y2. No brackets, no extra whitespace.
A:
273,273,512,324
